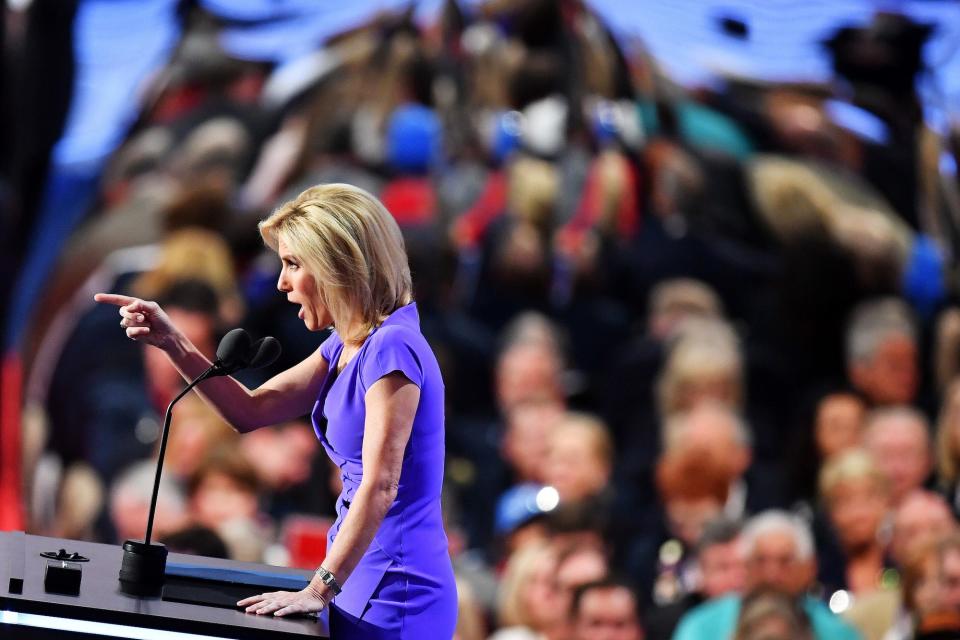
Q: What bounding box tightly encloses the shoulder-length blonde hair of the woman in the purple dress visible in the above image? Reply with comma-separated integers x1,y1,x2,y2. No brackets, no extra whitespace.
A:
259,184,413,342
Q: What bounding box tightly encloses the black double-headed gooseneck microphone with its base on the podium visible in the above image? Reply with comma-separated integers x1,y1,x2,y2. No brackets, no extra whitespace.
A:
120,328,280,596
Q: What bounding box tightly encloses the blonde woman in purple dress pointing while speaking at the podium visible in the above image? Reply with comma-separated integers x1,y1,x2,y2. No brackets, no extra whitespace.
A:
95,184,457,639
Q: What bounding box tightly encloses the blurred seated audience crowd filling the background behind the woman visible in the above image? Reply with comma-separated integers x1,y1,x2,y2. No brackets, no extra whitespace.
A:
9,0,960,640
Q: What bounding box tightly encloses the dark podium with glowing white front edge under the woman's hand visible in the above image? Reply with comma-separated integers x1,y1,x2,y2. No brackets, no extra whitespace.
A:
0,532,329,640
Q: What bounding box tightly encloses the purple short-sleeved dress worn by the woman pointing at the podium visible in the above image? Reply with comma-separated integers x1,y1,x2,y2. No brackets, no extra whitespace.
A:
313,303,457,640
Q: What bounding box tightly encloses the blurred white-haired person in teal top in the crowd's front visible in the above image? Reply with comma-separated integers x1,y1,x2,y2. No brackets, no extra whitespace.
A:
673,510,860,640
